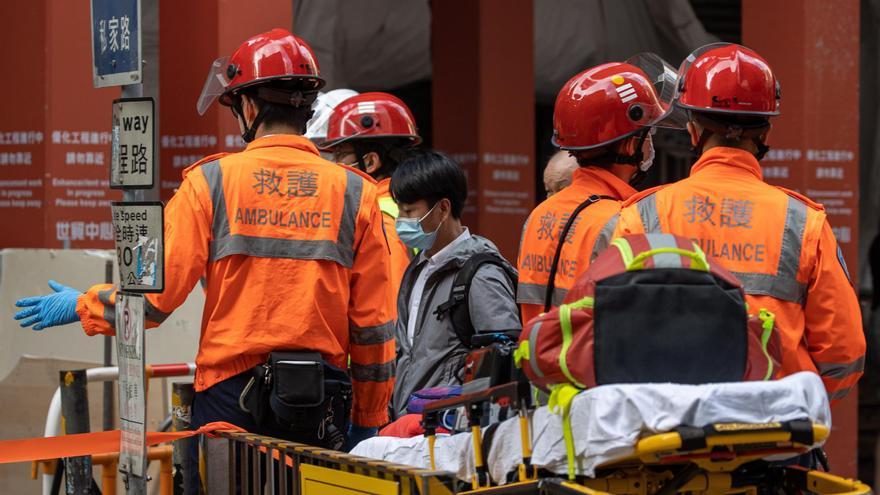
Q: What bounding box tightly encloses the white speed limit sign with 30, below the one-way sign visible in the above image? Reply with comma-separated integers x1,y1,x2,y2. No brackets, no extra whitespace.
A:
111,201,165,292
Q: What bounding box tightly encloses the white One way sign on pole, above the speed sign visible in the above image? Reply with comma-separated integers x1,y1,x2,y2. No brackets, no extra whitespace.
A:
110,98,156,189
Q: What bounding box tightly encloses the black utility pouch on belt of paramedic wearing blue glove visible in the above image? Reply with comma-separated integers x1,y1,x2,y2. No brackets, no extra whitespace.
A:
239,352,352,449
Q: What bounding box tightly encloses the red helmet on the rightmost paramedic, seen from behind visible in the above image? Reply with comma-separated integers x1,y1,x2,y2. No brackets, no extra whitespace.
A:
676,43,780,117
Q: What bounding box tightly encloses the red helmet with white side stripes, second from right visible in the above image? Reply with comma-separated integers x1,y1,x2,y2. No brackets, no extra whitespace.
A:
553,62,667,150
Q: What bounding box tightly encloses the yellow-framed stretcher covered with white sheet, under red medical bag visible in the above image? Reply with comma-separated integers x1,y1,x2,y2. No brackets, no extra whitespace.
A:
352,373,871,495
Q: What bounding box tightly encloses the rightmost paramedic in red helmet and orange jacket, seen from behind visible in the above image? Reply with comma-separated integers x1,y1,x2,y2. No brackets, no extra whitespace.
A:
615,44,865,401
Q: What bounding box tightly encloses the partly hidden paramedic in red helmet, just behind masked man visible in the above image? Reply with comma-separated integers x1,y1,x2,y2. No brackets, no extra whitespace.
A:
321,92,422,301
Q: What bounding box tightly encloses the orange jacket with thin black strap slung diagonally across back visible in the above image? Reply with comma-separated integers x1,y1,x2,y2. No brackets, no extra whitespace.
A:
516,166,636,323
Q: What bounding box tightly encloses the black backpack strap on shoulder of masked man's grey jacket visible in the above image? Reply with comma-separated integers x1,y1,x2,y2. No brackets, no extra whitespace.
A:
434,253,519,347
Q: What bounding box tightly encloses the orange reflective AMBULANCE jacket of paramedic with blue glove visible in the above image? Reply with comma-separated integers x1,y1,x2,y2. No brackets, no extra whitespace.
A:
77,135,396,426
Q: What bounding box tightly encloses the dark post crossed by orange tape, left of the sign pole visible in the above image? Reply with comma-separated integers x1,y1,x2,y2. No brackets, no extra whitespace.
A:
60,370,92,495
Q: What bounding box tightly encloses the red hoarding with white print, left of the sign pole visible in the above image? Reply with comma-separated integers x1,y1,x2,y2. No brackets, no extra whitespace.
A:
0,0,119,248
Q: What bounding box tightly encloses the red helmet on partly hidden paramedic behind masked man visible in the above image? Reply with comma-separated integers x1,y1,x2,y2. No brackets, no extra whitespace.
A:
321,93,422,149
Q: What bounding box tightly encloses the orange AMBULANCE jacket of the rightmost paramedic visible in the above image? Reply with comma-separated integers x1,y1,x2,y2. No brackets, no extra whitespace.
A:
615,147,865,401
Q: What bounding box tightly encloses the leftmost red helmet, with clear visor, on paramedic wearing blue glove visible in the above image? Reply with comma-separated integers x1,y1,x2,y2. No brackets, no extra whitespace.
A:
197,28,324,114
